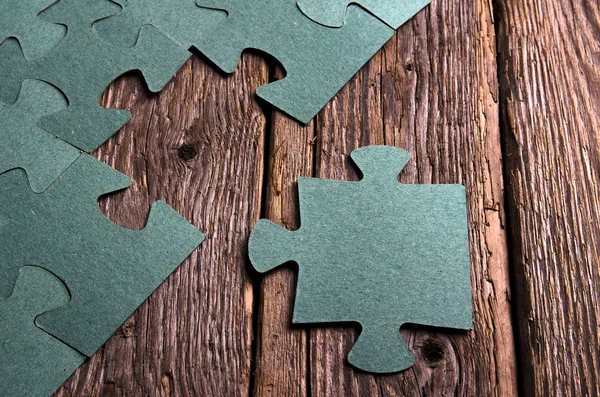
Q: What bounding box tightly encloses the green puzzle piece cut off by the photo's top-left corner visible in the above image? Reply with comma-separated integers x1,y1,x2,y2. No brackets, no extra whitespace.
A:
0,0,67,59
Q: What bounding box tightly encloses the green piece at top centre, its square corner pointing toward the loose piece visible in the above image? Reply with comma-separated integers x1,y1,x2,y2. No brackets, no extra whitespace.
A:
197,0,394,123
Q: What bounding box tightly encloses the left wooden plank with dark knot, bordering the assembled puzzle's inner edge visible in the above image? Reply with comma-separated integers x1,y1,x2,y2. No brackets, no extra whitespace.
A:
57,55,268,396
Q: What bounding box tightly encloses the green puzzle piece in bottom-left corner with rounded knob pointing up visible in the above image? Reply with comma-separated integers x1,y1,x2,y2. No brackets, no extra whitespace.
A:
0,266,85,397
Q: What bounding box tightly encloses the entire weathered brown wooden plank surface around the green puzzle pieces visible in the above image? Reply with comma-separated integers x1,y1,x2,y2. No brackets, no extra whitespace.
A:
52,0,600,397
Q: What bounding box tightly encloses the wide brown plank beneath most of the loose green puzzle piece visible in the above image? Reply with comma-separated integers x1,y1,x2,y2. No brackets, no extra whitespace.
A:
310,0,516,396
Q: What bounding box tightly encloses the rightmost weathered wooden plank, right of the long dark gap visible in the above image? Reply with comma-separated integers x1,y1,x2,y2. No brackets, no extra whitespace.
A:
497,0,600,396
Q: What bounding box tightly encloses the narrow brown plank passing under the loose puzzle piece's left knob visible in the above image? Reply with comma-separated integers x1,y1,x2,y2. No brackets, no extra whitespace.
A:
254,91,314,397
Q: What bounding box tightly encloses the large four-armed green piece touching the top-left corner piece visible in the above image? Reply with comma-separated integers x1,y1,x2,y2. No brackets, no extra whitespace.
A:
0,0,189,152
